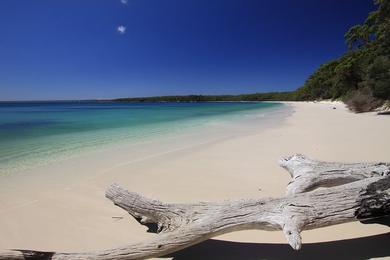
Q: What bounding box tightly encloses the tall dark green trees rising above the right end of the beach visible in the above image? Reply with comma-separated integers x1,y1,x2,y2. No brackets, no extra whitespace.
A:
296,0,390,110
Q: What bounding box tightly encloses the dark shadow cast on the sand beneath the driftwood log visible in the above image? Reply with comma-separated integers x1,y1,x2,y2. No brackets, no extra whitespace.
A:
169,233,390,260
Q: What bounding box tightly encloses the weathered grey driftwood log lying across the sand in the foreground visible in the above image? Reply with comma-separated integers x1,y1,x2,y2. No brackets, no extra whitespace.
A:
0,155,390,259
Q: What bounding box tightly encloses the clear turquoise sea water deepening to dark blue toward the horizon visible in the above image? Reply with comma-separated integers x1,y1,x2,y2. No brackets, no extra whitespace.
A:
0,102,281,174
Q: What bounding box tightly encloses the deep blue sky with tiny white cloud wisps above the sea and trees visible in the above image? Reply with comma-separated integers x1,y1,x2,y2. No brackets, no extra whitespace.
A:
0,0,375,100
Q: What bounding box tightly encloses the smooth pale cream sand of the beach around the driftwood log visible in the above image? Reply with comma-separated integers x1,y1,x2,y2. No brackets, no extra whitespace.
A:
0,102,390,259
